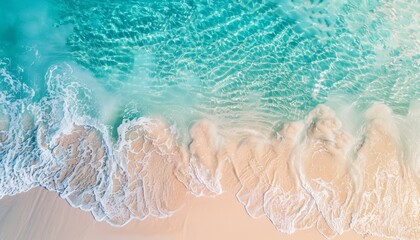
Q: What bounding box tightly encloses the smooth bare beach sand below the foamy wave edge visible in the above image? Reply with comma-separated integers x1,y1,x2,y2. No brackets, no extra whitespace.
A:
0,188,381,240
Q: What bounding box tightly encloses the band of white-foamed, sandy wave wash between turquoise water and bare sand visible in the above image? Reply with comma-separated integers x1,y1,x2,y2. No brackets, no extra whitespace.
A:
0,62,420,239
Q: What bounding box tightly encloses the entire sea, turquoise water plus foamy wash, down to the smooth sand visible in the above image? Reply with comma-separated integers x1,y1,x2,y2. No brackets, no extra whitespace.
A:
0,0,420,239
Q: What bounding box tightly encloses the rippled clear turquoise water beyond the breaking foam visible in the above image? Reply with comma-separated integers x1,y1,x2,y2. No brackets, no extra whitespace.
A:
1,1,420,125
